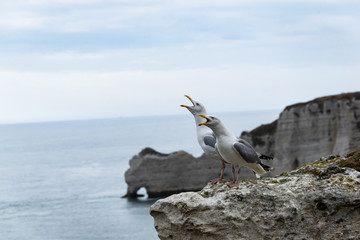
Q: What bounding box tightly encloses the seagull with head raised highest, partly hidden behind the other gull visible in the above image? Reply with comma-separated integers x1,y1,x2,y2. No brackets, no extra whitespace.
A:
180,95,225,184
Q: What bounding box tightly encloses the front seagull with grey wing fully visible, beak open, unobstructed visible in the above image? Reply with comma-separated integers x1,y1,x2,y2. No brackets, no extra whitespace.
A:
198,114,273,187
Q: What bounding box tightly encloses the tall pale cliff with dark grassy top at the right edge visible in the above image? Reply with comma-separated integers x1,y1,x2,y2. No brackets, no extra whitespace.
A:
241,92,360,175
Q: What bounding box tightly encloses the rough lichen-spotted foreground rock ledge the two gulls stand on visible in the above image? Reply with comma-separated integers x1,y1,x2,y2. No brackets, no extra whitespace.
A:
150,152,360,240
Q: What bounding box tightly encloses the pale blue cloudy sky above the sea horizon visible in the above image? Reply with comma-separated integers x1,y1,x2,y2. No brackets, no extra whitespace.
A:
0,0,360,124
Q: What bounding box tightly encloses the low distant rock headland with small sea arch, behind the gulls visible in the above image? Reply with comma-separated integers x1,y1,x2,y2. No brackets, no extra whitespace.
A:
124,148,255,197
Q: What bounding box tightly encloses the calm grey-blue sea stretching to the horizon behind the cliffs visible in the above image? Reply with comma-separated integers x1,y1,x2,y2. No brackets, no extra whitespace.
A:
0,110,280,240
